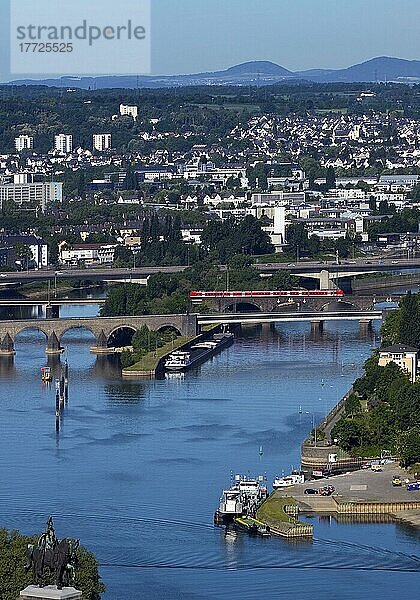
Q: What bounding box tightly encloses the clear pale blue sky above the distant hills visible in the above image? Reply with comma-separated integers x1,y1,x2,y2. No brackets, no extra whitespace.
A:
0,0,420,81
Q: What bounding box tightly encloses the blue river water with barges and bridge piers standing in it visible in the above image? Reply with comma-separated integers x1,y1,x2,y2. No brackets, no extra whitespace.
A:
0,307,420,600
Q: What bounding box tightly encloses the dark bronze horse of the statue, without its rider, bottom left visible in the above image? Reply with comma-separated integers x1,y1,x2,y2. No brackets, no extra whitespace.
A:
25,539,79,590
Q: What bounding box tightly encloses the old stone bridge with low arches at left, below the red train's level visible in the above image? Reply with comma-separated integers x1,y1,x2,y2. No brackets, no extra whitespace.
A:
0,314,198,356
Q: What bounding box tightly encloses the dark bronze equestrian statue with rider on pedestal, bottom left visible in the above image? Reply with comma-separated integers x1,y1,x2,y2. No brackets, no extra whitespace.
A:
25,517,79,590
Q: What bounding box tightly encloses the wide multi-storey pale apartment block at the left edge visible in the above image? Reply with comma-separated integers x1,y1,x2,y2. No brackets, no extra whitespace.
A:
0,181,63,212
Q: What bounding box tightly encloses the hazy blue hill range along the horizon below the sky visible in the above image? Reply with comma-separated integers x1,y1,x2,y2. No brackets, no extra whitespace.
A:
5,56,420,89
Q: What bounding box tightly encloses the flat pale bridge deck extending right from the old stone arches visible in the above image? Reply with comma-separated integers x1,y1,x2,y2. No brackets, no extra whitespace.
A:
197,310,383,325
